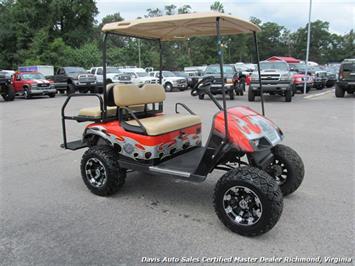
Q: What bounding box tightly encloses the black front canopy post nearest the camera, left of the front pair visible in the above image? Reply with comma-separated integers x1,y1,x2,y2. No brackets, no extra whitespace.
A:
216,17,229,141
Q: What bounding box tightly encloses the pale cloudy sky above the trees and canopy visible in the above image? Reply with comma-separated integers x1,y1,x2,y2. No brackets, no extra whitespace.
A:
96,0,355,34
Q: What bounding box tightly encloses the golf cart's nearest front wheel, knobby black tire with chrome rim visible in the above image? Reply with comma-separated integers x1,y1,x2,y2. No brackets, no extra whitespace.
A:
213,167,283,236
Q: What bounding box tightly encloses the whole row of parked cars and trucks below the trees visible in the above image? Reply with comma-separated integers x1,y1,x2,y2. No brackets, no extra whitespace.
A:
0,56,354,102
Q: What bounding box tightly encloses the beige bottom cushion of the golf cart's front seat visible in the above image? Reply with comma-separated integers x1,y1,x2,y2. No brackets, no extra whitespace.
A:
126,114,201,136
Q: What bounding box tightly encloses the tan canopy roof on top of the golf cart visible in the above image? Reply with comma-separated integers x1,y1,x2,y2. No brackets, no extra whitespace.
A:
102,12,260,41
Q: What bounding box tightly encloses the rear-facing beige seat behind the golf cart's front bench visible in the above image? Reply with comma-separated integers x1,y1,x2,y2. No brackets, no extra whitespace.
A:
79,83,144,119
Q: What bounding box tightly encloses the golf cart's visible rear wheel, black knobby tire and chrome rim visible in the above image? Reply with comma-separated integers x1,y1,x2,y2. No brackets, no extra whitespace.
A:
81,145,126,196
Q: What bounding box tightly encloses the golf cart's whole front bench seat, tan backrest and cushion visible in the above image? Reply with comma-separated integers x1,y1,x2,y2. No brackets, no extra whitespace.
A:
113,84,201,136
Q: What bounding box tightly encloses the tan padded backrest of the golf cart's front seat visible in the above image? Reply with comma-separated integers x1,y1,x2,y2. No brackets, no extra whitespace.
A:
113,84,165,107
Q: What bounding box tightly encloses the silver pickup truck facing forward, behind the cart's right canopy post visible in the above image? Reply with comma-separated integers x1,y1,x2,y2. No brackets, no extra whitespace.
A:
248,61,294,102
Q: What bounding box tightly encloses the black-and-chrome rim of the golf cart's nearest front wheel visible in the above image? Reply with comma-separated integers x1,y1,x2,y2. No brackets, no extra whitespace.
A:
223,186,263,226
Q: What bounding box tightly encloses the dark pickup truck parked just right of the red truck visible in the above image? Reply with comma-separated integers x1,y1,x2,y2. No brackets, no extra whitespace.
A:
48,67,97,94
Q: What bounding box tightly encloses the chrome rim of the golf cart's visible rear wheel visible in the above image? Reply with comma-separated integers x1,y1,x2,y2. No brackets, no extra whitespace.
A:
85,158,107,188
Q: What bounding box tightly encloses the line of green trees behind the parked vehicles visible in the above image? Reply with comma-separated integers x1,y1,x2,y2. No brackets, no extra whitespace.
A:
0,0,355,70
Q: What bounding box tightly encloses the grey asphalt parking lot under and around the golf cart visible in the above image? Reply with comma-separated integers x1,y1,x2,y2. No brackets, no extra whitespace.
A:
0,89,355,265
